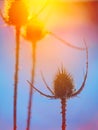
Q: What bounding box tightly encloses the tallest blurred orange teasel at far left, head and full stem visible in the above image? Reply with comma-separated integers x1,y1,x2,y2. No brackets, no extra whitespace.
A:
0,0,28,130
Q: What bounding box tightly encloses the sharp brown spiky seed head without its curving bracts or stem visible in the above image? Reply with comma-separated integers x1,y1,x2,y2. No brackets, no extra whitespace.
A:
53,67,74,98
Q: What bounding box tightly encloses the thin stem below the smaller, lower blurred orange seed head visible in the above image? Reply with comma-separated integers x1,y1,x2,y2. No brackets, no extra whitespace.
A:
27,43,36,130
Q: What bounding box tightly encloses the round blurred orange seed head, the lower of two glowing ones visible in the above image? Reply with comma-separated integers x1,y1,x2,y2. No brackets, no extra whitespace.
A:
23,20,45,42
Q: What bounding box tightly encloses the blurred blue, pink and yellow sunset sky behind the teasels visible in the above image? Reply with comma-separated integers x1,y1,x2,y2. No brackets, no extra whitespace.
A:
0,0,98,130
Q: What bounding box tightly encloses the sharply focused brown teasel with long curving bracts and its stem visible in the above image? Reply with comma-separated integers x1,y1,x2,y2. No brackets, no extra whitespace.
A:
28,43,88,130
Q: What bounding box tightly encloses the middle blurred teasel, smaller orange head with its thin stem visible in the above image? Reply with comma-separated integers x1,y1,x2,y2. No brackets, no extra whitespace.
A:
23,19,45,130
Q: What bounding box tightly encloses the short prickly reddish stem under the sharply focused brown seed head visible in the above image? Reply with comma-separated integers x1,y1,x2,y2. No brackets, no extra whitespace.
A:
61,98,67,130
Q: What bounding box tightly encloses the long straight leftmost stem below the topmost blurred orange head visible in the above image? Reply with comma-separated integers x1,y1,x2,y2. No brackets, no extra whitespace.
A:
13,27,20,130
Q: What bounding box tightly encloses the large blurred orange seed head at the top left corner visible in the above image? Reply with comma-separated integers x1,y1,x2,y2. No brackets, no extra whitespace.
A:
6,0,28,27
